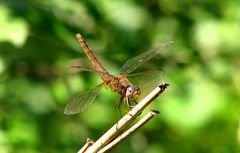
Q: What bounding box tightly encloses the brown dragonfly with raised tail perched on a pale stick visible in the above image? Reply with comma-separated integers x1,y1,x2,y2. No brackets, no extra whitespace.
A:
64,33,173,115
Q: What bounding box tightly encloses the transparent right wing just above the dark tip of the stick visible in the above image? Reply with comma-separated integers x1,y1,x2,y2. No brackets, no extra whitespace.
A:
127,70,163,100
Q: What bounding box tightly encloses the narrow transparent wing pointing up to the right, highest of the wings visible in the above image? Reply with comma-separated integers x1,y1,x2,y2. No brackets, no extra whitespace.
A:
120,41,173,74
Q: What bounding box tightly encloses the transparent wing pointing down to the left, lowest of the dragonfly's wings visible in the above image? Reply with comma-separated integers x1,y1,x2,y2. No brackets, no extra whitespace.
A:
64,86,100,115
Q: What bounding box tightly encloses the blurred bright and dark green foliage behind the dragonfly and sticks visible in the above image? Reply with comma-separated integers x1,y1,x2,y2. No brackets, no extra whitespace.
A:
0,0,240,153
